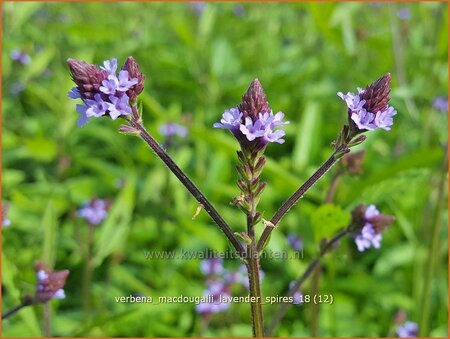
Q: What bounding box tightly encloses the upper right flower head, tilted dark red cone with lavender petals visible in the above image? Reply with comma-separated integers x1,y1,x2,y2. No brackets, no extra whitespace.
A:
337,73,397,132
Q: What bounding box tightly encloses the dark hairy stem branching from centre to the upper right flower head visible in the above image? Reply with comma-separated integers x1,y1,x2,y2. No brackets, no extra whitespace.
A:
257,152,339,251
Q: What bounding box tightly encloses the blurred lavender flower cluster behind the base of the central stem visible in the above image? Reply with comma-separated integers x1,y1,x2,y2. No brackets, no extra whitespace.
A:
196,258,264,315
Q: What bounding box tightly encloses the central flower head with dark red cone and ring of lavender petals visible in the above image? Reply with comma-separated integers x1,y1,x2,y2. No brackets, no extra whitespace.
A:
213,79,289,151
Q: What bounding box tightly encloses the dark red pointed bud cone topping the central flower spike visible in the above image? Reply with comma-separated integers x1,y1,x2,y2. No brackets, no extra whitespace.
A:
239,79,270,121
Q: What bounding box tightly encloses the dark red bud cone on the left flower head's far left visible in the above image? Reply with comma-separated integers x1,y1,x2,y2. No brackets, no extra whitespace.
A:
67,58,107,99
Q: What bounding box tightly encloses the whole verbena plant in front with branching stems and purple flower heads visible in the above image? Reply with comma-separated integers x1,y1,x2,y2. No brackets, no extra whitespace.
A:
68,57,396,337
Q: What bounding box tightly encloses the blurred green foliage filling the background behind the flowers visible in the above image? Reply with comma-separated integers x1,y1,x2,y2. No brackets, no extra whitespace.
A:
2,2,448,337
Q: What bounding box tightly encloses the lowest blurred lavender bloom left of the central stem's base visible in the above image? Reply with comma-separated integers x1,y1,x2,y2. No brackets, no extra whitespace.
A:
196,280,230,314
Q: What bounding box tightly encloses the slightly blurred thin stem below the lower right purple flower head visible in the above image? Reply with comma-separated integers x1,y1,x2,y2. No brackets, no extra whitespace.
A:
267,227,349,337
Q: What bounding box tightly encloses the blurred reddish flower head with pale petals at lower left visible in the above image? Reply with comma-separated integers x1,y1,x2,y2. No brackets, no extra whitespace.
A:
35,262,69,303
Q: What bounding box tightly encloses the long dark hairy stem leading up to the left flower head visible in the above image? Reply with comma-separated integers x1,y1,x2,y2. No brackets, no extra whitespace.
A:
129,111,245,257
